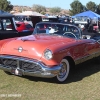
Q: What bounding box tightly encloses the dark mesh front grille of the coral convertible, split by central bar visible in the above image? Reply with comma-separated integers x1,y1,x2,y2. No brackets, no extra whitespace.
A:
0,57,41,72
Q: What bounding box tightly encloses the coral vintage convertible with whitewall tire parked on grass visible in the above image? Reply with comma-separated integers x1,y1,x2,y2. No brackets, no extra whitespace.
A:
0,22,100,83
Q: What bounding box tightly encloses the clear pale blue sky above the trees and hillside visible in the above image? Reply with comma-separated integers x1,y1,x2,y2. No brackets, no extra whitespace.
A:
7,0,100,10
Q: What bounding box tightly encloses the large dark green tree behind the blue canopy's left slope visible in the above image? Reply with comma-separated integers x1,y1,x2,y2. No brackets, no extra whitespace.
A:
70,0,84,15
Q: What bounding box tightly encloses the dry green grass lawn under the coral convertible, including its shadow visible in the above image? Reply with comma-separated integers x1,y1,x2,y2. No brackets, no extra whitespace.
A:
0,60,100,100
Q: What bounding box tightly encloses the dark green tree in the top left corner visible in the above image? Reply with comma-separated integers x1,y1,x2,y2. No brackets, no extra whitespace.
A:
0,0,13,12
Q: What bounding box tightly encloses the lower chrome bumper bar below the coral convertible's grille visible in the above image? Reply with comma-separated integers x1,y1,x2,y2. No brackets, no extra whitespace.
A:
0,65,61,78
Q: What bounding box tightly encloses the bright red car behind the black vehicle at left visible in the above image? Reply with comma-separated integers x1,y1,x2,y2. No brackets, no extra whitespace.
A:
16,22,34,32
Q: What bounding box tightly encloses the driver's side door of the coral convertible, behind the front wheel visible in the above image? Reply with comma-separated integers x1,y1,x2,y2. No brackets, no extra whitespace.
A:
73,39,100,63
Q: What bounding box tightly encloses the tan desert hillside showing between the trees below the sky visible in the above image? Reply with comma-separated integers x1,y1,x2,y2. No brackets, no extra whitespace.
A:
11,5,69,15
